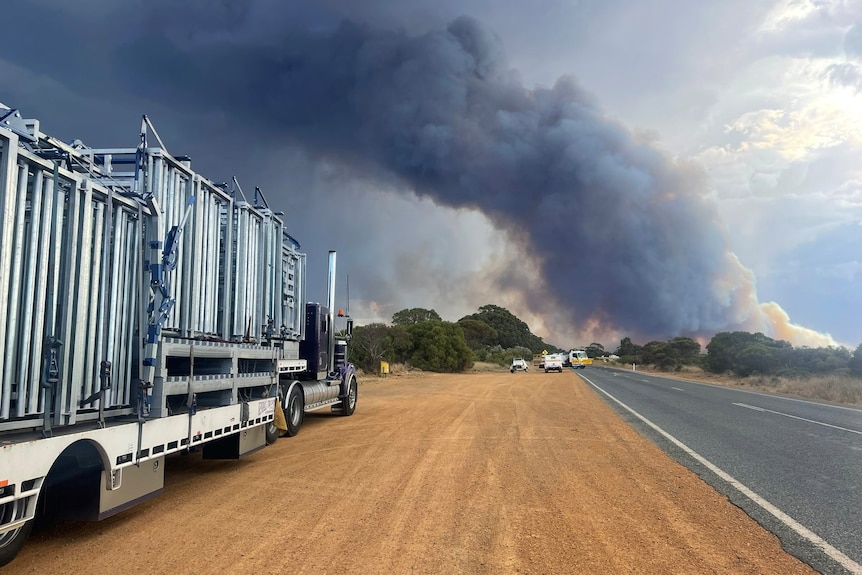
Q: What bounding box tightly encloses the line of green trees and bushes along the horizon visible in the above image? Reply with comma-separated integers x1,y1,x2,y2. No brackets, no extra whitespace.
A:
349,304,862,378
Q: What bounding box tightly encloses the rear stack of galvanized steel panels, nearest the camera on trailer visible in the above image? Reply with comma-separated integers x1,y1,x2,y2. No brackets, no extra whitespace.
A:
0,127,141,429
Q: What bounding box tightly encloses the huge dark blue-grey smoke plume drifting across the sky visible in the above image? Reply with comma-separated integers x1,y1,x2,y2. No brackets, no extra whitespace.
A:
1,1,836,346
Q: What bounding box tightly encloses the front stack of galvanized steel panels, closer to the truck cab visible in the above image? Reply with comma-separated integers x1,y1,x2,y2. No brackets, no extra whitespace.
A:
133,148,305,342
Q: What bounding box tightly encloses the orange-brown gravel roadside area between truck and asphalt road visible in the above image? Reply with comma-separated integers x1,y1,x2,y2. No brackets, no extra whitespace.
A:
3,370,814,575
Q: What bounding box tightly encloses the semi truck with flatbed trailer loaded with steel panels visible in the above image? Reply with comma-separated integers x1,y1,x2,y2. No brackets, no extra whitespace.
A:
0,104,358,565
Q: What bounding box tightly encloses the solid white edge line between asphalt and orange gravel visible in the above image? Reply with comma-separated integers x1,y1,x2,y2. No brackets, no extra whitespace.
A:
581,374,862,575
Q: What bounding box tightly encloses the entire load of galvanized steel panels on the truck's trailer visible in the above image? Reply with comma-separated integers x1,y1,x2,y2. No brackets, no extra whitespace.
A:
0,111,305,430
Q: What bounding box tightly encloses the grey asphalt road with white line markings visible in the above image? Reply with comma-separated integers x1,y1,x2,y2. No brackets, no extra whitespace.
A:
579,367,862,573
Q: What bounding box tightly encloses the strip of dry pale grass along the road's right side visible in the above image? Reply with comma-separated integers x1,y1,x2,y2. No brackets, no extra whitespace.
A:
629,366,862,407
